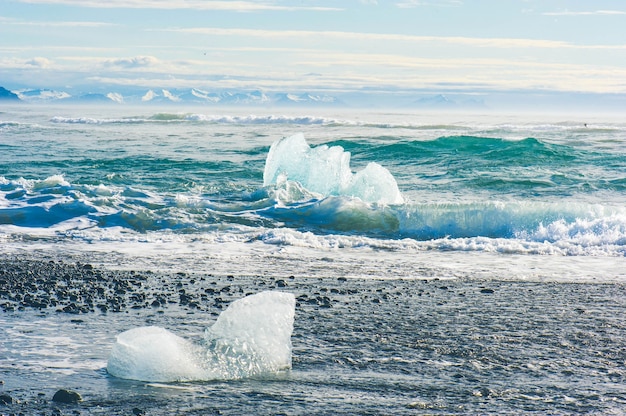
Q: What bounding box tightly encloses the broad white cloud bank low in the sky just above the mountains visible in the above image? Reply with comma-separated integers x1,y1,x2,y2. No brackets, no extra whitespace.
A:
0,47,626,92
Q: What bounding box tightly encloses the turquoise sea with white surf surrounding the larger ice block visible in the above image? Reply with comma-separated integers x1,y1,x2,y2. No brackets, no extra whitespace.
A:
0,108,626,257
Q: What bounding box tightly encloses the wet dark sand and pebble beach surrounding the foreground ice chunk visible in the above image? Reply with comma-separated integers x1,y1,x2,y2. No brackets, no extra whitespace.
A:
0,256,626,415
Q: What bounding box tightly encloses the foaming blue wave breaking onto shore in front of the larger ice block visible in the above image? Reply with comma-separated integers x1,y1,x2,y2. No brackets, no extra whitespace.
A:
0,175,626,256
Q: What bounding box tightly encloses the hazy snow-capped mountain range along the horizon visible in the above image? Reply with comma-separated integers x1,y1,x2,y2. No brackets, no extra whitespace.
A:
0,86,626,114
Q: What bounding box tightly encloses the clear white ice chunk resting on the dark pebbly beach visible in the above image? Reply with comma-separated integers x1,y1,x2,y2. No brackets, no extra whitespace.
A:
107,292,295,382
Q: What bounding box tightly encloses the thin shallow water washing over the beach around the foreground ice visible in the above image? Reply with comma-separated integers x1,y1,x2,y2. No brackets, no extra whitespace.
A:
0,260,626,414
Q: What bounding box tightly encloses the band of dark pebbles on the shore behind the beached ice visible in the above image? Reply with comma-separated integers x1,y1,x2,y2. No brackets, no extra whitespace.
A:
0,258,339,315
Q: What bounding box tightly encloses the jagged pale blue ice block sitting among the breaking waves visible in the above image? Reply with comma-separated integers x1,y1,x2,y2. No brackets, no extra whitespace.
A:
263,134,404,204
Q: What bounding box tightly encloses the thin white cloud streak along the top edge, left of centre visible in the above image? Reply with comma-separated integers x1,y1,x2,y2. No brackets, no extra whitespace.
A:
18,0,343,12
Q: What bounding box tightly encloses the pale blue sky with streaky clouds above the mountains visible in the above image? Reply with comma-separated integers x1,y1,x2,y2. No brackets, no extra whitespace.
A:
0,0,626,93
